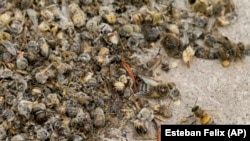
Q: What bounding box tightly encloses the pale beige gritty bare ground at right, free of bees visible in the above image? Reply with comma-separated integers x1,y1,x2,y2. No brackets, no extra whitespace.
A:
129,0,250,140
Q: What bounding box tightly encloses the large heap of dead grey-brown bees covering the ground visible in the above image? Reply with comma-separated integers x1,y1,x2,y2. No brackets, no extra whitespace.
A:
0,0,244,141
